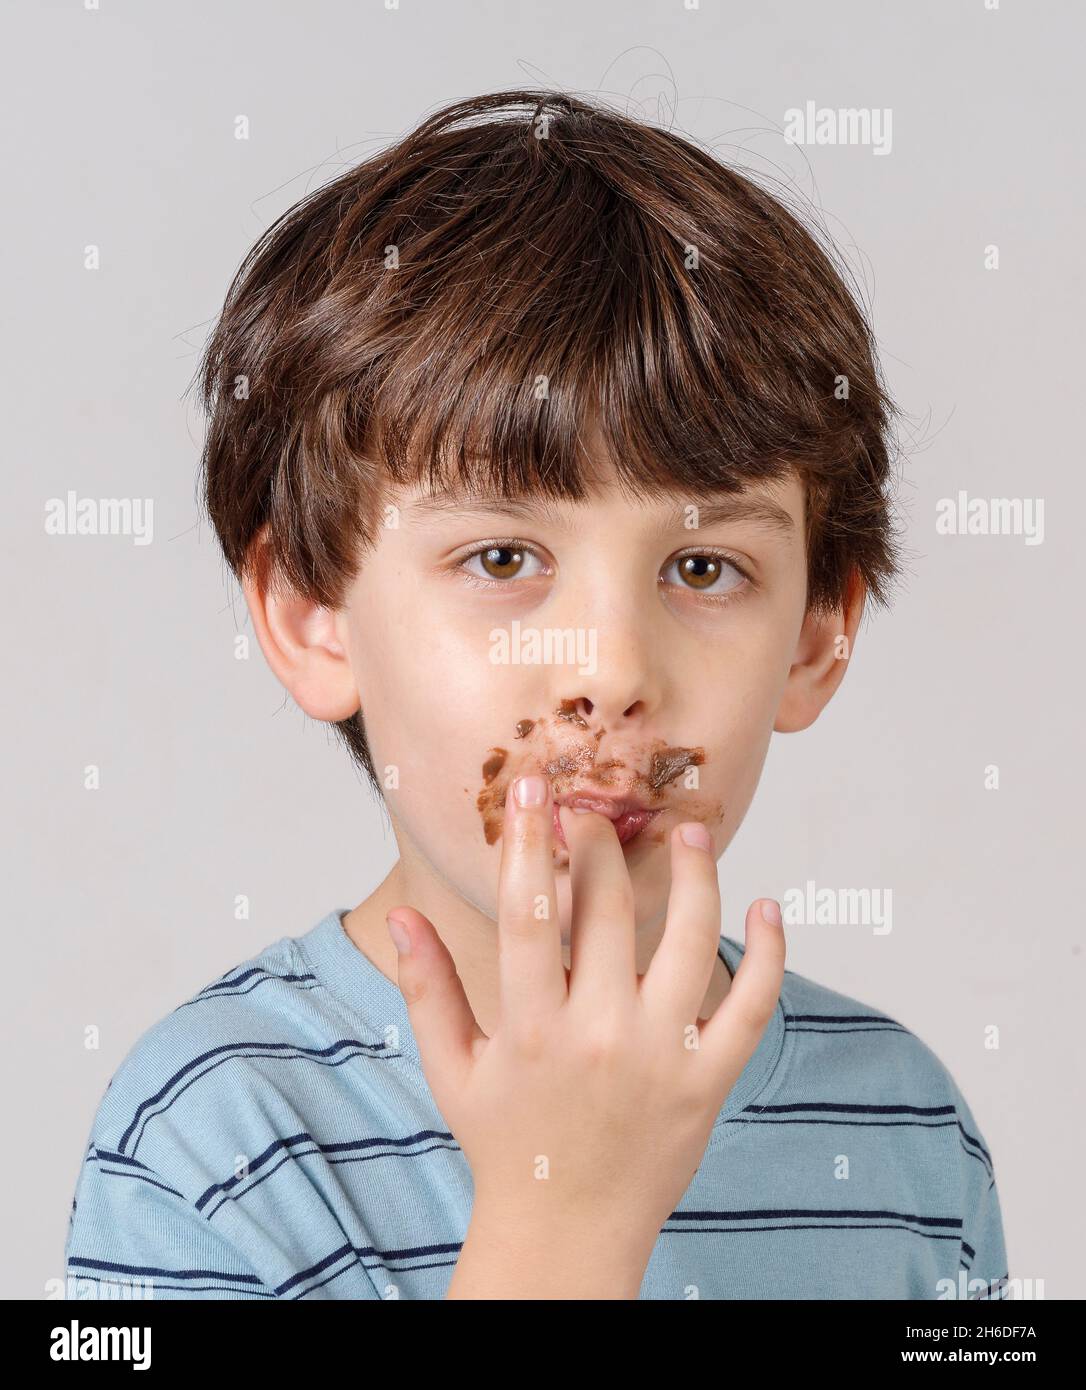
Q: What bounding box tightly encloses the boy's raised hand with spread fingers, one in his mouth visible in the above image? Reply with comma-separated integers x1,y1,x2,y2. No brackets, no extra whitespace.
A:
389,778,786,1269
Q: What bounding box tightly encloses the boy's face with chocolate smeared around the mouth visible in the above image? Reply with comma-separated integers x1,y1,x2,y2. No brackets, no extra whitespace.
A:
326,461,858,937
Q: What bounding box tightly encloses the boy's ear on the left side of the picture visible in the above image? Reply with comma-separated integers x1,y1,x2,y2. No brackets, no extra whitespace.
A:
242,528,360,723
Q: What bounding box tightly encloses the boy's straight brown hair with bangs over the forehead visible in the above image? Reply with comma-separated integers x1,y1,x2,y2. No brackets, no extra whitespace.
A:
190,90,898,794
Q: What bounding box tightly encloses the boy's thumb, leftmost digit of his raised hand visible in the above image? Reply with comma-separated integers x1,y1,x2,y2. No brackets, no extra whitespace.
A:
388,908,487,1109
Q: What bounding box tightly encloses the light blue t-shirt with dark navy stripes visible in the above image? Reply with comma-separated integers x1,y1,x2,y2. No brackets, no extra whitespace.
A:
65,909,1008,1300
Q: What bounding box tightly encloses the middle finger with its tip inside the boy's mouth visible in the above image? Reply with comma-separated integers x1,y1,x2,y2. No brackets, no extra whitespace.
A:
558,806,637,1008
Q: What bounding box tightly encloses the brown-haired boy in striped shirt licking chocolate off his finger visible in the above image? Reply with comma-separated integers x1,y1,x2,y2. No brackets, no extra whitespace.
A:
59,92,1008,1298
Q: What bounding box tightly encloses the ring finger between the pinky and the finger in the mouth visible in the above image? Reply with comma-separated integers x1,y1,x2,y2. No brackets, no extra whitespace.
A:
640,821,720,1029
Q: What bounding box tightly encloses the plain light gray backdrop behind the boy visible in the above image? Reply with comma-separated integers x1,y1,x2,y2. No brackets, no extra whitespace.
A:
0,0,1085,1298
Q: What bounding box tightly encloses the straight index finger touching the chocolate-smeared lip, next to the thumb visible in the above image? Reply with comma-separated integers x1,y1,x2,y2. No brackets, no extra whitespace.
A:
498,776,567,1033
